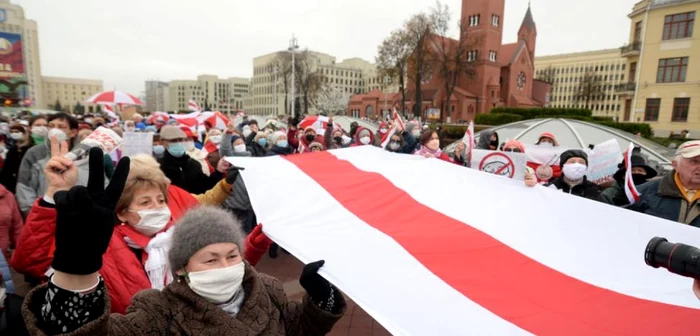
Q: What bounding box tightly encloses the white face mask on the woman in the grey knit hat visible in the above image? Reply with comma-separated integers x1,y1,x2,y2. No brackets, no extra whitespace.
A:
187,262,245,304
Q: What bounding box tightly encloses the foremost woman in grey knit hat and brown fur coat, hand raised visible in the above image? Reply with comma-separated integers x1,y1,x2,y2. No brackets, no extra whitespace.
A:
22,160,346,336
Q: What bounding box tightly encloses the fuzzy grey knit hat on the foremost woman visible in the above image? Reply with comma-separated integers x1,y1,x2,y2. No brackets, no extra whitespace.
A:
168,206,244,274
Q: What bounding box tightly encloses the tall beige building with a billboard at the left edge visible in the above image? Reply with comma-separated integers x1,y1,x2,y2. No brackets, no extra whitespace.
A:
0,0,46,108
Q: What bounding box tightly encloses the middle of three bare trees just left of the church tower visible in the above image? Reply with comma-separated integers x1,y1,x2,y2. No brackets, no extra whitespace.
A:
403,13,432,116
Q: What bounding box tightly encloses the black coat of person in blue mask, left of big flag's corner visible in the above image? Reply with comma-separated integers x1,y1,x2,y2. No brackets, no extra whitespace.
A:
158,151,224,194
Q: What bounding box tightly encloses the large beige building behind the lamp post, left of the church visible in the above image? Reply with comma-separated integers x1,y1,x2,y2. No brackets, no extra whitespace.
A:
249,51,394,115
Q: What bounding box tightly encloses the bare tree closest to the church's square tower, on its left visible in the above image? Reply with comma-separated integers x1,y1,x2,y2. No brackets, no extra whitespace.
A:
430,1,478,120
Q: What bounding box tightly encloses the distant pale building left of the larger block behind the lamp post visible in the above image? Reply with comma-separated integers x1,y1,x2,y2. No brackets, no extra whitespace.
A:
167,75,250,112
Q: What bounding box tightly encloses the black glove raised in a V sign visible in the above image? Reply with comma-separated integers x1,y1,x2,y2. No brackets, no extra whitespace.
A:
51,148,130,275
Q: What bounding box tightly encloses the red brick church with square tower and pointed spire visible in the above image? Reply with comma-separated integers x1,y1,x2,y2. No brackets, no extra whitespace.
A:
348,0,551,123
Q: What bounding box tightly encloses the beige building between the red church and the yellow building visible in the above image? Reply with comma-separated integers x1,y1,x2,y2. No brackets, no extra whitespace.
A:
535,49,629,118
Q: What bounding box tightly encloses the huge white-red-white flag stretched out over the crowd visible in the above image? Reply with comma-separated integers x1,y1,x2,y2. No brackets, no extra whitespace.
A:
229,146,700,336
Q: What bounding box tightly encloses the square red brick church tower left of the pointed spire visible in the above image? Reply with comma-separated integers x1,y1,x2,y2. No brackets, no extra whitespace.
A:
459,0,507,113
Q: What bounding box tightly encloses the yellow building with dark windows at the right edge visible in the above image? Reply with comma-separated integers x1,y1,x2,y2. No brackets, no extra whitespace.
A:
617,0,700,137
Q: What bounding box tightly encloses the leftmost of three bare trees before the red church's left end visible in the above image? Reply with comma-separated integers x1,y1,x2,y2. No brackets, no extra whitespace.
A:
375,29,411,117
